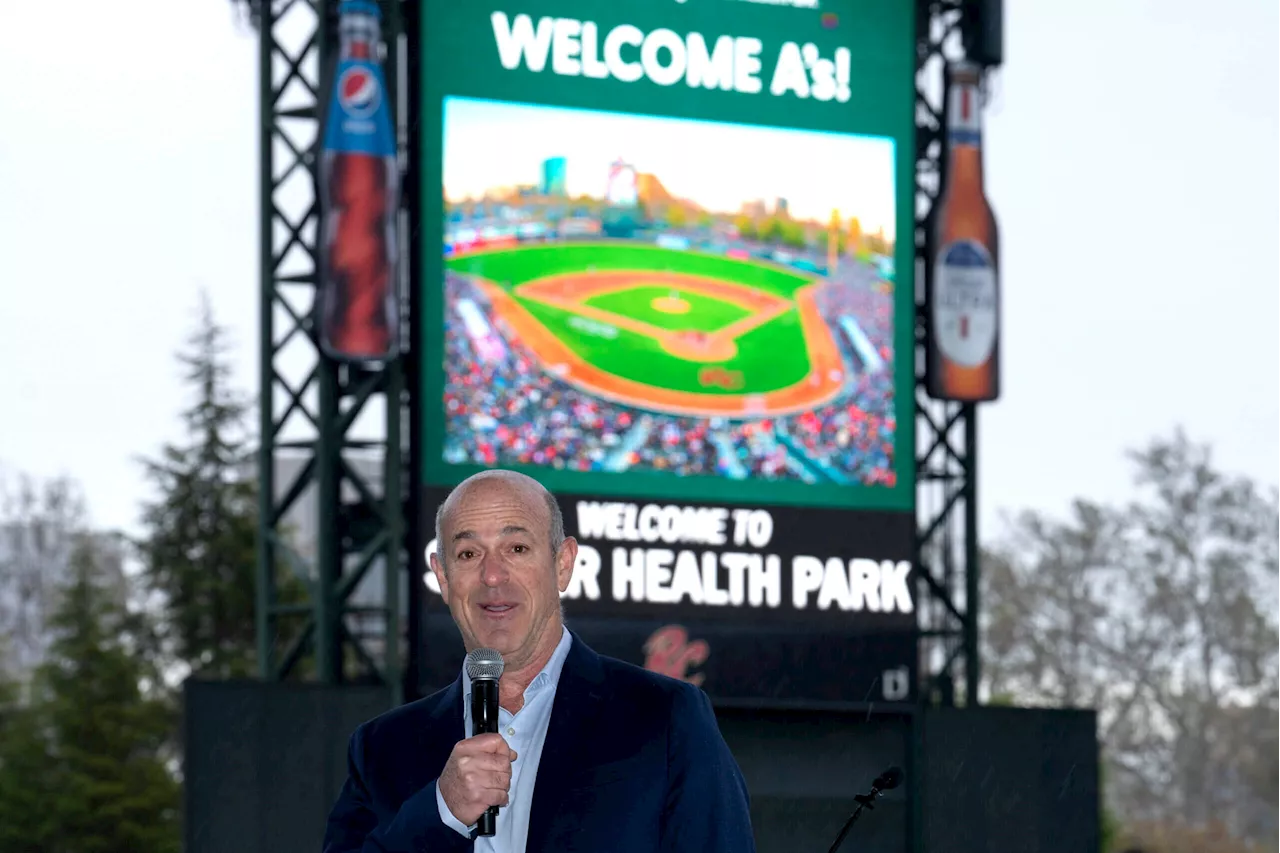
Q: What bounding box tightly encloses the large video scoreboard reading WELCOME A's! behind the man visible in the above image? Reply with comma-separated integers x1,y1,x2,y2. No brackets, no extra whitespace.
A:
415,0,916,704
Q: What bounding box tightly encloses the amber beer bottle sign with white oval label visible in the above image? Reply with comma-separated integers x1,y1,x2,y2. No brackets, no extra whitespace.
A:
925,63,1000,402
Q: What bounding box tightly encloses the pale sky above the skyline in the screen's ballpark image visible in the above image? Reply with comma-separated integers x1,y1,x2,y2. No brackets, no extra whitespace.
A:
443,97,896,242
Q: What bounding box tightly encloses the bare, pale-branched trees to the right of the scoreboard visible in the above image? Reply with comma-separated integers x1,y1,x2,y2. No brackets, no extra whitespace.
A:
980,430,1280,853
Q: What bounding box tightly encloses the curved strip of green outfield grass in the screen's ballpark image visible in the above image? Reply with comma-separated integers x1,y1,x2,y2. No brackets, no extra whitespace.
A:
444,241,813,296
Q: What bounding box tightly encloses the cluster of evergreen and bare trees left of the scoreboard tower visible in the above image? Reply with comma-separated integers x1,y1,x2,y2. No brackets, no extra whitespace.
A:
0,300,257,853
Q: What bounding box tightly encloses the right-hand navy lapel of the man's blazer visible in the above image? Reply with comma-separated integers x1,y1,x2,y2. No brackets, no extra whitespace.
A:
525,631,604,853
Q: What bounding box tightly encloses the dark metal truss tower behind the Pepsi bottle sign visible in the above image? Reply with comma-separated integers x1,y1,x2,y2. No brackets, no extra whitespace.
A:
250,0,408,702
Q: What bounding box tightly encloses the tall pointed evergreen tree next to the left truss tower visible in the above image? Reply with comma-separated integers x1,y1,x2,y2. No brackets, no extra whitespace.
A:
138,297,257,679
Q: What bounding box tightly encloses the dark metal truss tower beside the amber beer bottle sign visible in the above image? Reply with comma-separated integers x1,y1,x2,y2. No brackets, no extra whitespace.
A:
915,0,982,707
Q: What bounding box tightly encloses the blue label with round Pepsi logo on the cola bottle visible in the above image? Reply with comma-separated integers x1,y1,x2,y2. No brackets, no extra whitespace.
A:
324,59,396,158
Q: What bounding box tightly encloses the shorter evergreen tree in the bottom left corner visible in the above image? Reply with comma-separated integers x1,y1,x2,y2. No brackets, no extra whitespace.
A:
0,535,180,853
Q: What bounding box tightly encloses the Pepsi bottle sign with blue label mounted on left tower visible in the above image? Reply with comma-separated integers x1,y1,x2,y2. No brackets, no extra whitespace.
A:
316,0,399,362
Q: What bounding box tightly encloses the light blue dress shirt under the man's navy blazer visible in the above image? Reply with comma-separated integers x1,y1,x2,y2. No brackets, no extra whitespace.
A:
435,628,572,853
